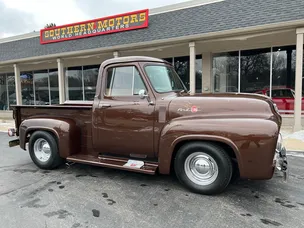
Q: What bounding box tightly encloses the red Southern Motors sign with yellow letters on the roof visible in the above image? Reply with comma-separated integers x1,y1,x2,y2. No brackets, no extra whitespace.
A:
40,9,149,44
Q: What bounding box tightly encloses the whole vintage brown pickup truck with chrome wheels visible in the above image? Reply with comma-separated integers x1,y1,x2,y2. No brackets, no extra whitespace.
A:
9,56,287,194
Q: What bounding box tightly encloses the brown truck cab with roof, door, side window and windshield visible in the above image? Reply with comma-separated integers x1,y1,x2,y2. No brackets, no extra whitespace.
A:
92,58,182,159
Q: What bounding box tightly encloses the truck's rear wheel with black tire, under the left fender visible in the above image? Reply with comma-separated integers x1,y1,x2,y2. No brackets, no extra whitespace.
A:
29,131,63,169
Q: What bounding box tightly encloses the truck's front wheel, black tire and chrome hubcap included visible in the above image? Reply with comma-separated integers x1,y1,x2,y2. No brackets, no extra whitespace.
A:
174,142,233,195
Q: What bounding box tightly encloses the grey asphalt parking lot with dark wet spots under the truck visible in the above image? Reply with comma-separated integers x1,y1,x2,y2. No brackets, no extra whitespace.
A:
0,133,304,228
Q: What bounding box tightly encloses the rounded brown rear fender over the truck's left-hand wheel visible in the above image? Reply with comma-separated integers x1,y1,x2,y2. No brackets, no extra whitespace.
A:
19,118,81,158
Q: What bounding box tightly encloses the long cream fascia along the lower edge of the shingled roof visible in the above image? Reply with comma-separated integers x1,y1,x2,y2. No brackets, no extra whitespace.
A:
0,19,304,65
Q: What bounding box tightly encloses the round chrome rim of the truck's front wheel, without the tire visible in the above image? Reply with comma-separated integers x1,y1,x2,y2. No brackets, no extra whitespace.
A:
184,152,218,185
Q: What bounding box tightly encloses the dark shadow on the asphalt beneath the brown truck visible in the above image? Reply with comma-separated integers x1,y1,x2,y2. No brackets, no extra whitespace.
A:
52,161,284,199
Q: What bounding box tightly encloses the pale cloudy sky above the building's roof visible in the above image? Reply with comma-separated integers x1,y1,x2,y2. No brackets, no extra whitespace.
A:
0,0,188,38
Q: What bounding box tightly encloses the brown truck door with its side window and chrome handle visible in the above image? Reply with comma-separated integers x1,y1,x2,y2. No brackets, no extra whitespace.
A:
92,64,155,158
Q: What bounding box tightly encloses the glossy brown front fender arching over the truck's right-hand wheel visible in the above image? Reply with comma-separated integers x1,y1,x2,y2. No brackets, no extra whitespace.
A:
159,118,279,179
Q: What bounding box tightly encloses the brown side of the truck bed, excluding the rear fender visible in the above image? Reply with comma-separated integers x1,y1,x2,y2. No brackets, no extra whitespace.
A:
12,101,93,153
